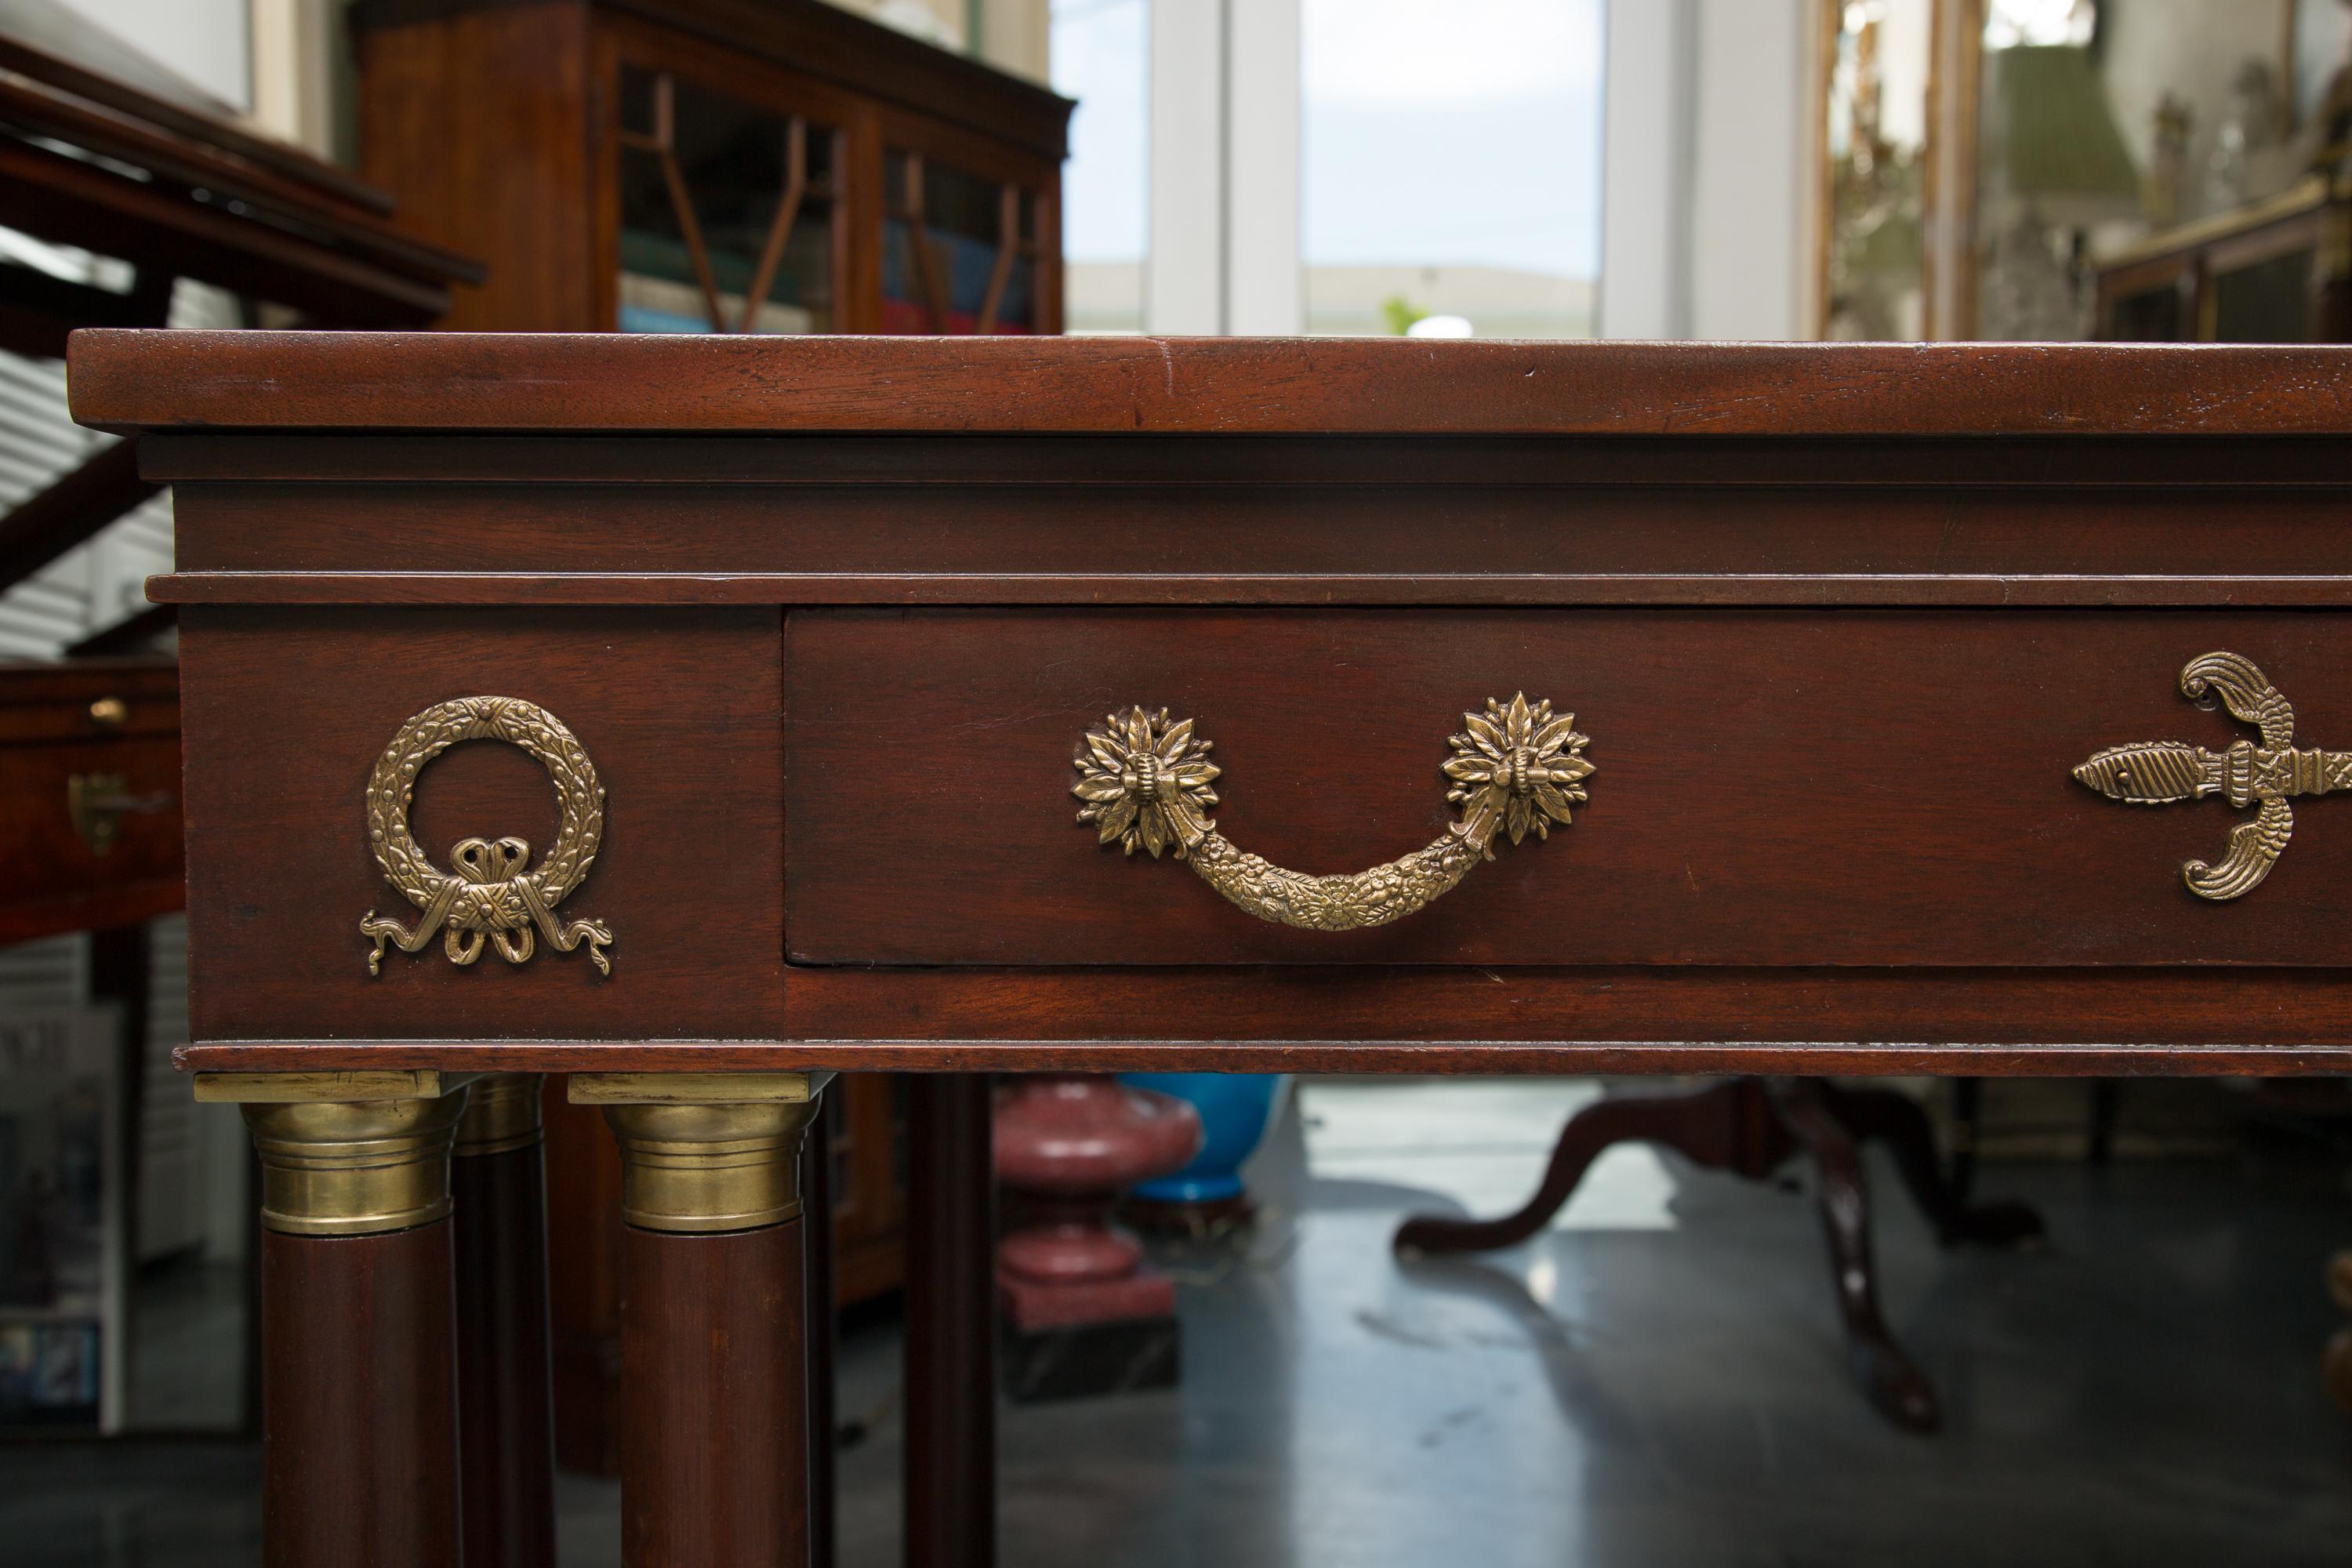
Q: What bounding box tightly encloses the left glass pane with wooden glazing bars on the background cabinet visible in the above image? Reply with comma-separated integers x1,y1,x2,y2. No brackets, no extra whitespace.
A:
619,66,837,332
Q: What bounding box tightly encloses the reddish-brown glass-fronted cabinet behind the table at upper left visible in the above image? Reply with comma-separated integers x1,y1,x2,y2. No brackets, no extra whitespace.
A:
350,0,1073,334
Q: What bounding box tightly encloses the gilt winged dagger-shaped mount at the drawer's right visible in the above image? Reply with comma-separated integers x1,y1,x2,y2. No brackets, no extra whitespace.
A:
2074,654,2352,900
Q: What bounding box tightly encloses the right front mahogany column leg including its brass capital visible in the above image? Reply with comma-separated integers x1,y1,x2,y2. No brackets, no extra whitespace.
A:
588,1074,816,1568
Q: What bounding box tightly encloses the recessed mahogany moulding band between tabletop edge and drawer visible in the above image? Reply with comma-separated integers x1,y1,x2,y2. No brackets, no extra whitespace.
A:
151,463,2352,607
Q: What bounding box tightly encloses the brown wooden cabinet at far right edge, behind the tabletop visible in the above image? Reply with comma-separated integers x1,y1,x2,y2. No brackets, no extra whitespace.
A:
2093,174,2352,343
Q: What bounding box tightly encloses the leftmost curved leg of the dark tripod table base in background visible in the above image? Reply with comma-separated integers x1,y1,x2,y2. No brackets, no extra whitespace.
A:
1395,1079,1778,1253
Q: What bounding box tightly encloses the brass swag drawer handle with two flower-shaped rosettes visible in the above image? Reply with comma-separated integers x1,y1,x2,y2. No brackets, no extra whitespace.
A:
1070,694,1592,931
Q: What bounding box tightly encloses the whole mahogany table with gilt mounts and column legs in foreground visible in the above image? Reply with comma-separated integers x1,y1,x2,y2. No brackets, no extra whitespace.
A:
60,332,2352,1566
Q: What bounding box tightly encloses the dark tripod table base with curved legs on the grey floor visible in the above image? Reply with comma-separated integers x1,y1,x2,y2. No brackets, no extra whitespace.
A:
1397,1079,2042,1432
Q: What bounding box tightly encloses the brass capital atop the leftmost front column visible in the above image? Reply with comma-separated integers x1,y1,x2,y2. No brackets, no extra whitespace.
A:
242,1091,466,1236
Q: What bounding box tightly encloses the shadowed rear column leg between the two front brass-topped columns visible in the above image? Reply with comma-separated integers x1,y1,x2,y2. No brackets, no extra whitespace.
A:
449,1072,555,1568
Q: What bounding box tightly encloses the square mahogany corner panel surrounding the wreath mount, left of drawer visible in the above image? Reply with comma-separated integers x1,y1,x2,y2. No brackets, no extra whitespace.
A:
181,609,783,1039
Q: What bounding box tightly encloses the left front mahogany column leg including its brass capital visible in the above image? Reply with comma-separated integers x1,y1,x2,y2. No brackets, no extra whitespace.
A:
245,1093,463,1568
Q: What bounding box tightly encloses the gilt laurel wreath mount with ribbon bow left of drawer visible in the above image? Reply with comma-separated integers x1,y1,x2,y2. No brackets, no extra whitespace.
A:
360,696,612,973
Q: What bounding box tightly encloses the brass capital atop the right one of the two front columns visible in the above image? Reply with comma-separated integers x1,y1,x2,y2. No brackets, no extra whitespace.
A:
604,1100,818,1232
